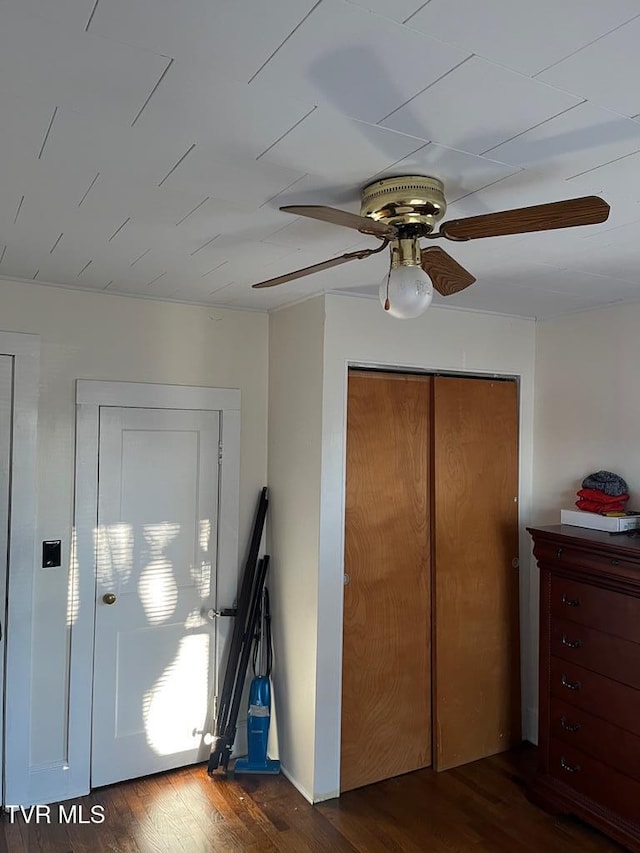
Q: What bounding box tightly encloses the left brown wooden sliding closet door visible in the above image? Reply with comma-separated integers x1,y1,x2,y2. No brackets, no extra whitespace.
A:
340,371,431,791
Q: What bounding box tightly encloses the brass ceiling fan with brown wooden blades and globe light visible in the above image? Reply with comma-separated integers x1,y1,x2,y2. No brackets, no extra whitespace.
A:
253,175,609,318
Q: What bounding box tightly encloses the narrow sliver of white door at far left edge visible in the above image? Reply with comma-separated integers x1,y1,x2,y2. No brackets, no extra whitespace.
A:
0,355,13,803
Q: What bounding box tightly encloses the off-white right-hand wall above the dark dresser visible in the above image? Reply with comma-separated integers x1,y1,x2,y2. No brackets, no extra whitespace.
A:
534,303,640,524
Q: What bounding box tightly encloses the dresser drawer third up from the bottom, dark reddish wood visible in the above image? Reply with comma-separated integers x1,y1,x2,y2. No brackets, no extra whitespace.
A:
550,657,640,735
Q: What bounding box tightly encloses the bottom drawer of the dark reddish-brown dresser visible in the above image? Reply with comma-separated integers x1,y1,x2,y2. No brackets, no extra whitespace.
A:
549,740,640,823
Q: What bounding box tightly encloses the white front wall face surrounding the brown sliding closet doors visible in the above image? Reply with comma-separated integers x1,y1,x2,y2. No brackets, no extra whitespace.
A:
316,295,537,801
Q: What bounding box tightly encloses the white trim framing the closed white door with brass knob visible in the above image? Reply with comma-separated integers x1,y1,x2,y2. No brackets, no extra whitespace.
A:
67,379,240,799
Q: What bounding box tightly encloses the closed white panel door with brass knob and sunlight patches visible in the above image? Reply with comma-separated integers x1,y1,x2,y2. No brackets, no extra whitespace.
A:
91,407,220,786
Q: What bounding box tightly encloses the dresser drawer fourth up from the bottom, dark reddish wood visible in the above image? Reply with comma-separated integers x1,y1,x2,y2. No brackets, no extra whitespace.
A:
551,617,640,689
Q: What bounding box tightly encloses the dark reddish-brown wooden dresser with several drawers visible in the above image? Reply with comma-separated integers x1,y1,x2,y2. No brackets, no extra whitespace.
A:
529,525,640,853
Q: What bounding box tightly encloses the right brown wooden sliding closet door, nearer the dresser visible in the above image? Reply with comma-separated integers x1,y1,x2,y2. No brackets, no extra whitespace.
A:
433,377,520,770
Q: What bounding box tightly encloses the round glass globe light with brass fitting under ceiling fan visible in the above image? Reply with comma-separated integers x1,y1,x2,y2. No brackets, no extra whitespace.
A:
380,239,433,320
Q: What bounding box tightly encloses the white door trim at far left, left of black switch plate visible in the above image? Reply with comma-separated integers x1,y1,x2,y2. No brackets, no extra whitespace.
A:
0,331,40,803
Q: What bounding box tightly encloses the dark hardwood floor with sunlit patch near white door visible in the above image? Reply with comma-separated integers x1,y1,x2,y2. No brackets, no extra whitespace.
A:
0,749,623,853
